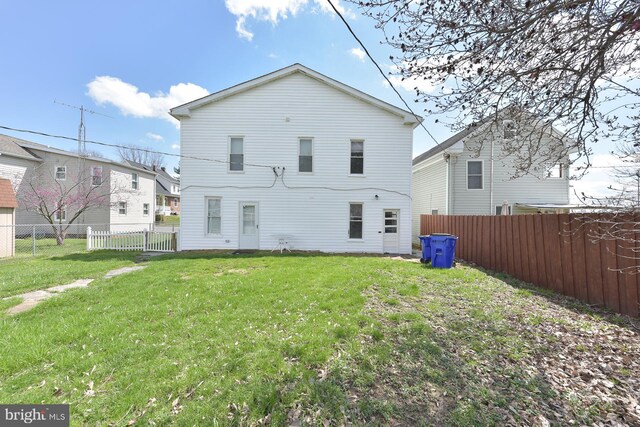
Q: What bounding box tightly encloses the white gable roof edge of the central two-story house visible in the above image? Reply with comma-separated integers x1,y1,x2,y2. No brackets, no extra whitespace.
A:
169,64,422,127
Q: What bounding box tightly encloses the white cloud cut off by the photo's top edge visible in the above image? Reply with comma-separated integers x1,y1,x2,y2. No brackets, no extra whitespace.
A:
224,0,355,41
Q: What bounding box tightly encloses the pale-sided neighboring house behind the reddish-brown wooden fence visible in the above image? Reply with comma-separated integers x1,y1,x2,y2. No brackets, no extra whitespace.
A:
412,113,569,237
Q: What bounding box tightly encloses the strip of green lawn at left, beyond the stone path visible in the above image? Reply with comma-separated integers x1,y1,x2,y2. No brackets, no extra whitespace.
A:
0,251,139,298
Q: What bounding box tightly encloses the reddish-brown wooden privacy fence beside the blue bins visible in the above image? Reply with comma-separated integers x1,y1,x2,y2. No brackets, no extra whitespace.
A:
420,214,640,317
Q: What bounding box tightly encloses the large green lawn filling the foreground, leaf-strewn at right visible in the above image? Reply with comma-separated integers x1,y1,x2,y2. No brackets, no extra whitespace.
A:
0,253,640,426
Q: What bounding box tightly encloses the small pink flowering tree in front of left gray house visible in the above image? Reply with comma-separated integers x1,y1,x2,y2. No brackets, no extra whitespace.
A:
18,160,131,245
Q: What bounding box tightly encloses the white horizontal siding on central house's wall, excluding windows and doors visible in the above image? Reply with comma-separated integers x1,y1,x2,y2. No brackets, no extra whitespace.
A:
180,73,413,253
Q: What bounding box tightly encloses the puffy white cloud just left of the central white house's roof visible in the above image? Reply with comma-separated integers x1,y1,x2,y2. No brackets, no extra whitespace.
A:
87,76,209,125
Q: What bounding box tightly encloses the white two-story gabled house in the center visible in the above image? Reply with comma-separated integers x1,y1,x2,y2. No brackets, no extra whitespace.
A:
171,64,420,253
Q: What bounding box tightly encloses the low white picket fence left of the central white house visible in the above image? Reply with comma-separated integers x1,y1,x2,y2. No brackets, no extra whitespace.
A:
87,227,177,252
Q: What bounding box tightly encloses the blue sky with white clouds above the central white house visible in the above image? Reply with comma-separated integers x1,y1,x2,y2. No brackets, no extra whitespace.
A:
0,0,606,197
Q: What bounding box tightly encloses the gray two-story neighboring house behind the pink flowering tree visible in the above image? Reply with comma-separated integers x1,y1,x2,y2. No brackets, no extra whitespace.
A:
0,135,156,229
